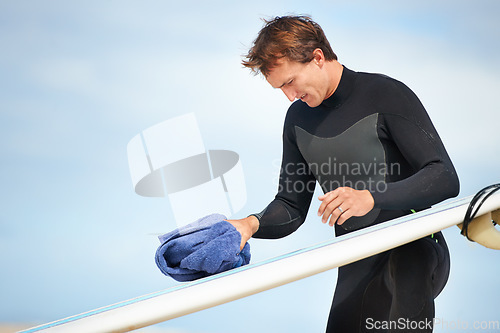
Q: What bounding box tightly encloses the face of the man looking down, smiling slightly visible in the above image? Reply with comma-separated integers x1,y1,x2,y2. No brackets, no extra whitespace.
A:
266,54,329,107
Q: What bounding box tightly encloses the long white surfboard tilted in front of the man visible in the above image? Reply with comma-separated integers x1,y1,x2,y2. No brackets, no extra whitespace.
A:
22,192,500,333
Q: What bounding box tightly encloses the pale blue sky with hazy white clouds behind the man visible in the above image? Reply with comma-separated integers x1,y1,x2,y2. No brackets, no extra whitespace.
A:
0,1,500,333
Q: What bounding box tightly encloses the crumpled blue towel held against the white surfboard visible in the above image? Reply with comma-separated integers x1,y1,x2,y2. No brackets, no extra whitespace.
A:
156,214,250,282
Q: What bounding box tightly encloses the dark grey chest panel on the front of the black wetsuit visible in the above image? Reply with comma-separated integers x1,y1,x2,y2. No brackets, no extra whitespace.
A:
295,114,386,230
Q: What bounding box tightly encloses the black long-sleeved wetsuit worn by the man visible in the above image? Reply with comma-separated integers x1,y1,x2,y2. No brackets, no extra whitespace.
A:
254,67,459,333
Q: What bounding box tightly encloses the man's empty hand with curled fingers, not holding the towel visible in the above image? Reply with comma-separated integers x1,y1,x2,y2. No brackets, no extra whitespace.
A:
318,187,374,227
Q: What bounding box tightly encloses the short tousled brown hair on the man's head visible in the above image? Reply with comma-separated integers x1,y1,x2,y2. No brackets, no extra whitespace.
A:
242,16,337,76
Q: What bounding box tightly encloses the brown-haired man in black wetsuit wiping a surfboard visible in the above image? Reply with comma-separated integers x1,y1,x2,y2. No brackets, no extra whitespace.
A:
230,16,459,333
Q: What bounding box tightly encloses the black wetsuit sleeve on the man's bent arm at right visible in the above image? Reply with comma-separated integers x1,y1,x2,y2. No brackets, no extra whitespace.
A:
372,80,459,209
